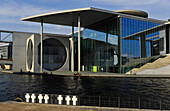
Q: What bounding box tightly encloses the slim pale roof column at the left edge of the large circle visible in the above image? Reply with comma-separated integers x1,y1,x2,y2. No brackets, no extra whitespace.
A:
40,20,43,73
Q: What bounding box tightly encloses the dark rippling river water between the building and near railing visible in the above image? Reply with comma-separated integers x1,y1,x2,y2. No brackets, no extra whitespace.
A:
0,74,170,101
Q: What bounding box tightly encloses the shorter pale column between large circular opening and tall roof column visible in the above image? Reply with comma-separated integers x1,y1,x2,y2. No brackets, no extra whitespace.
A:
71,22,74,72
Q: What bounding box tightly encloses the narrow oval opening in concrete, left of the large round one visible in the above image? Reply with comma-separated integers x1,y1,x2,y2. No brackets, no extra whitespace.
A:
27,40,33,70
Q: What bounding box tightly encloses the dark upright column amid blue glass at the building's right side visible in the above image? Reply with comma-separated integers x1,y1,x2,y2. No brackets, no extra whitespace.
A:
140,34,146,58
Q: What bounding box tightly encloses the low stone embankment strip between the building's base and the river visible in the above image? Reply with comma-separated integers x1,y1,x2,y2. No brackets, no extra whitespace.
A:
0,70,170,79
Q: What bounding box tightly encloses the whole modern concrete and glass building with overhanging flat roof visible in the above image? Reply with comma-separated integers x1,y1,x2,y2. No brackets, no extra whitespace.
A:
10,7,170,73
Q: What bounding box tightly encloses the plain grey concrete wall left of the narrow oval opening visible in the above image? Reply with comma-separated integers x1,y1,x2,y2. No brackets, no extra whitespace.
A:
12,32,32,72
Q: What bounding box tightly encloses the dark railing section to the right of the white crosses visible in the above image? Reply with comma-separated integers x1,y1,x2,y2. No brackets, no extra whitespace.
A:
79,96,161,109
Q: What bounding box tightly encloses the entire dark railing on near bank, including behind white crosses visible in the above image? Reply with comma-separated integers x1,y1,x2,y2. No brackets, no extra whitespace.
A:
20,94,170,110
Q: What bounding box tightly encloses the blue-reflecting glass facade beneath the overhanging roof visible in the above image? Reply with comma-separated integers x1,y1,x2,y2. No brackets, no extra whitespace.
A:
74,17,163,73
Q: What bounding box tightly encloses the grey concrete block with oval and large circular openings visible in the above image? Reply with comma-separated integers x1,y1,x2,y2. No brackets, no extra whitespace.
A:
12,32,70,72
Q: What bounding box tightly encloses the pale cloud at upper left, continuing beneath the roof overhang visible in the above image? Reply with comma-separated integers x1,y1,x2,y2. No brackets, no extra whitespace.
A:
0,1,70,34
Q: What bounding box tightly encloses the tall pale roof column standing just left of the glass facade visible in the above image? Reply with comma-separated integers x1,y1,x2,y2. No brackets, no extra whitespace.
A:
78,16,80,72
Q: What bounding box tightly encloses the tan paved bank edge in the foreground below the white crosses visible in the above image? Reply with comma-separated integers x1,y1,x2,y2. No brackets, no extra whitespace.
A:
0,101,166,111
